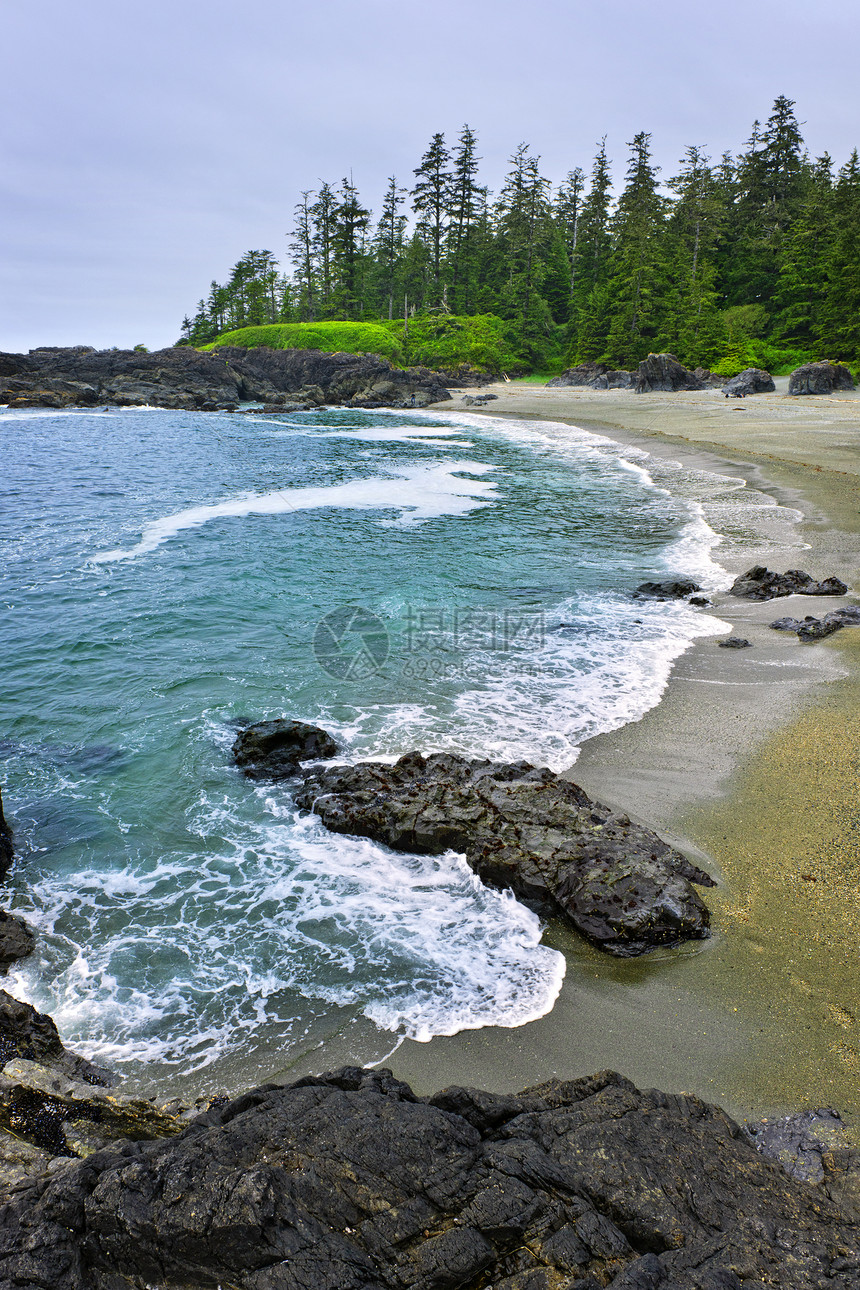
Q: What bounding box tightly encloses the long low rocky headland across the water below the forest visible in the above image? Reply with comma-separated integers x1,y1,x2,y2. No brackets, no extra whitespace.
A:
0,346,450,410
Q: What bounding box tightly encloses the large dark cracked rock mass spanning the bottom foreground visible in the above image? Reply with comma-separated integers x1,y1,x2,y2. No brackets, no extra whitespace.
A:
0,1068,860,1290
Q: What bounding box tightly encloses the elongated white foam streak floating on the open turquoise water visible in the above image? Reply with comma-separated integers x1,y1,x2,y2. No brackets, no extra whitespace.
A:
90,462,496,564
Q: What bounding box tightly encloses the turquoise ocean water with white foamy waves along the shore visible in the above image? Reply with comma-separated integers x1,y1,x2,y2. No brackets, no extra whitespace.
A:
0,399,778,1090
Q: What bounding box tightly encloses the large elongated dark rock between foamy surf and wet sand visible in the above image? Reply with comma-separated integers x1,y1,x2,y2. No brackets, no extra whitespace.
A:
297,752,713,956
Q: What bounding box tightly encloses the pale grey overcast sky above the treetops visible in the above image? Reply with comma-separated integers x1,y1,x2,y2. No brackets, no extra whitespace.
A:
0,0,860,351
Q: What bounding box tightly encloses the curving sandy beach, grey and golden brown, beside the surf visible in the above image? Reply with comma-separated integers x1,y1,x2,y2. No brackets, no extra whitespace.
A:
387,381,860,1139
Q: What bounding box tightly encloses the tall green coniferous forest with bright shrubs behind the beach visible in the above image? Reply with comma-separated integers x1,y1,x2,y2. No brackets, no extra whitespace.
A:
179,97,860,374
